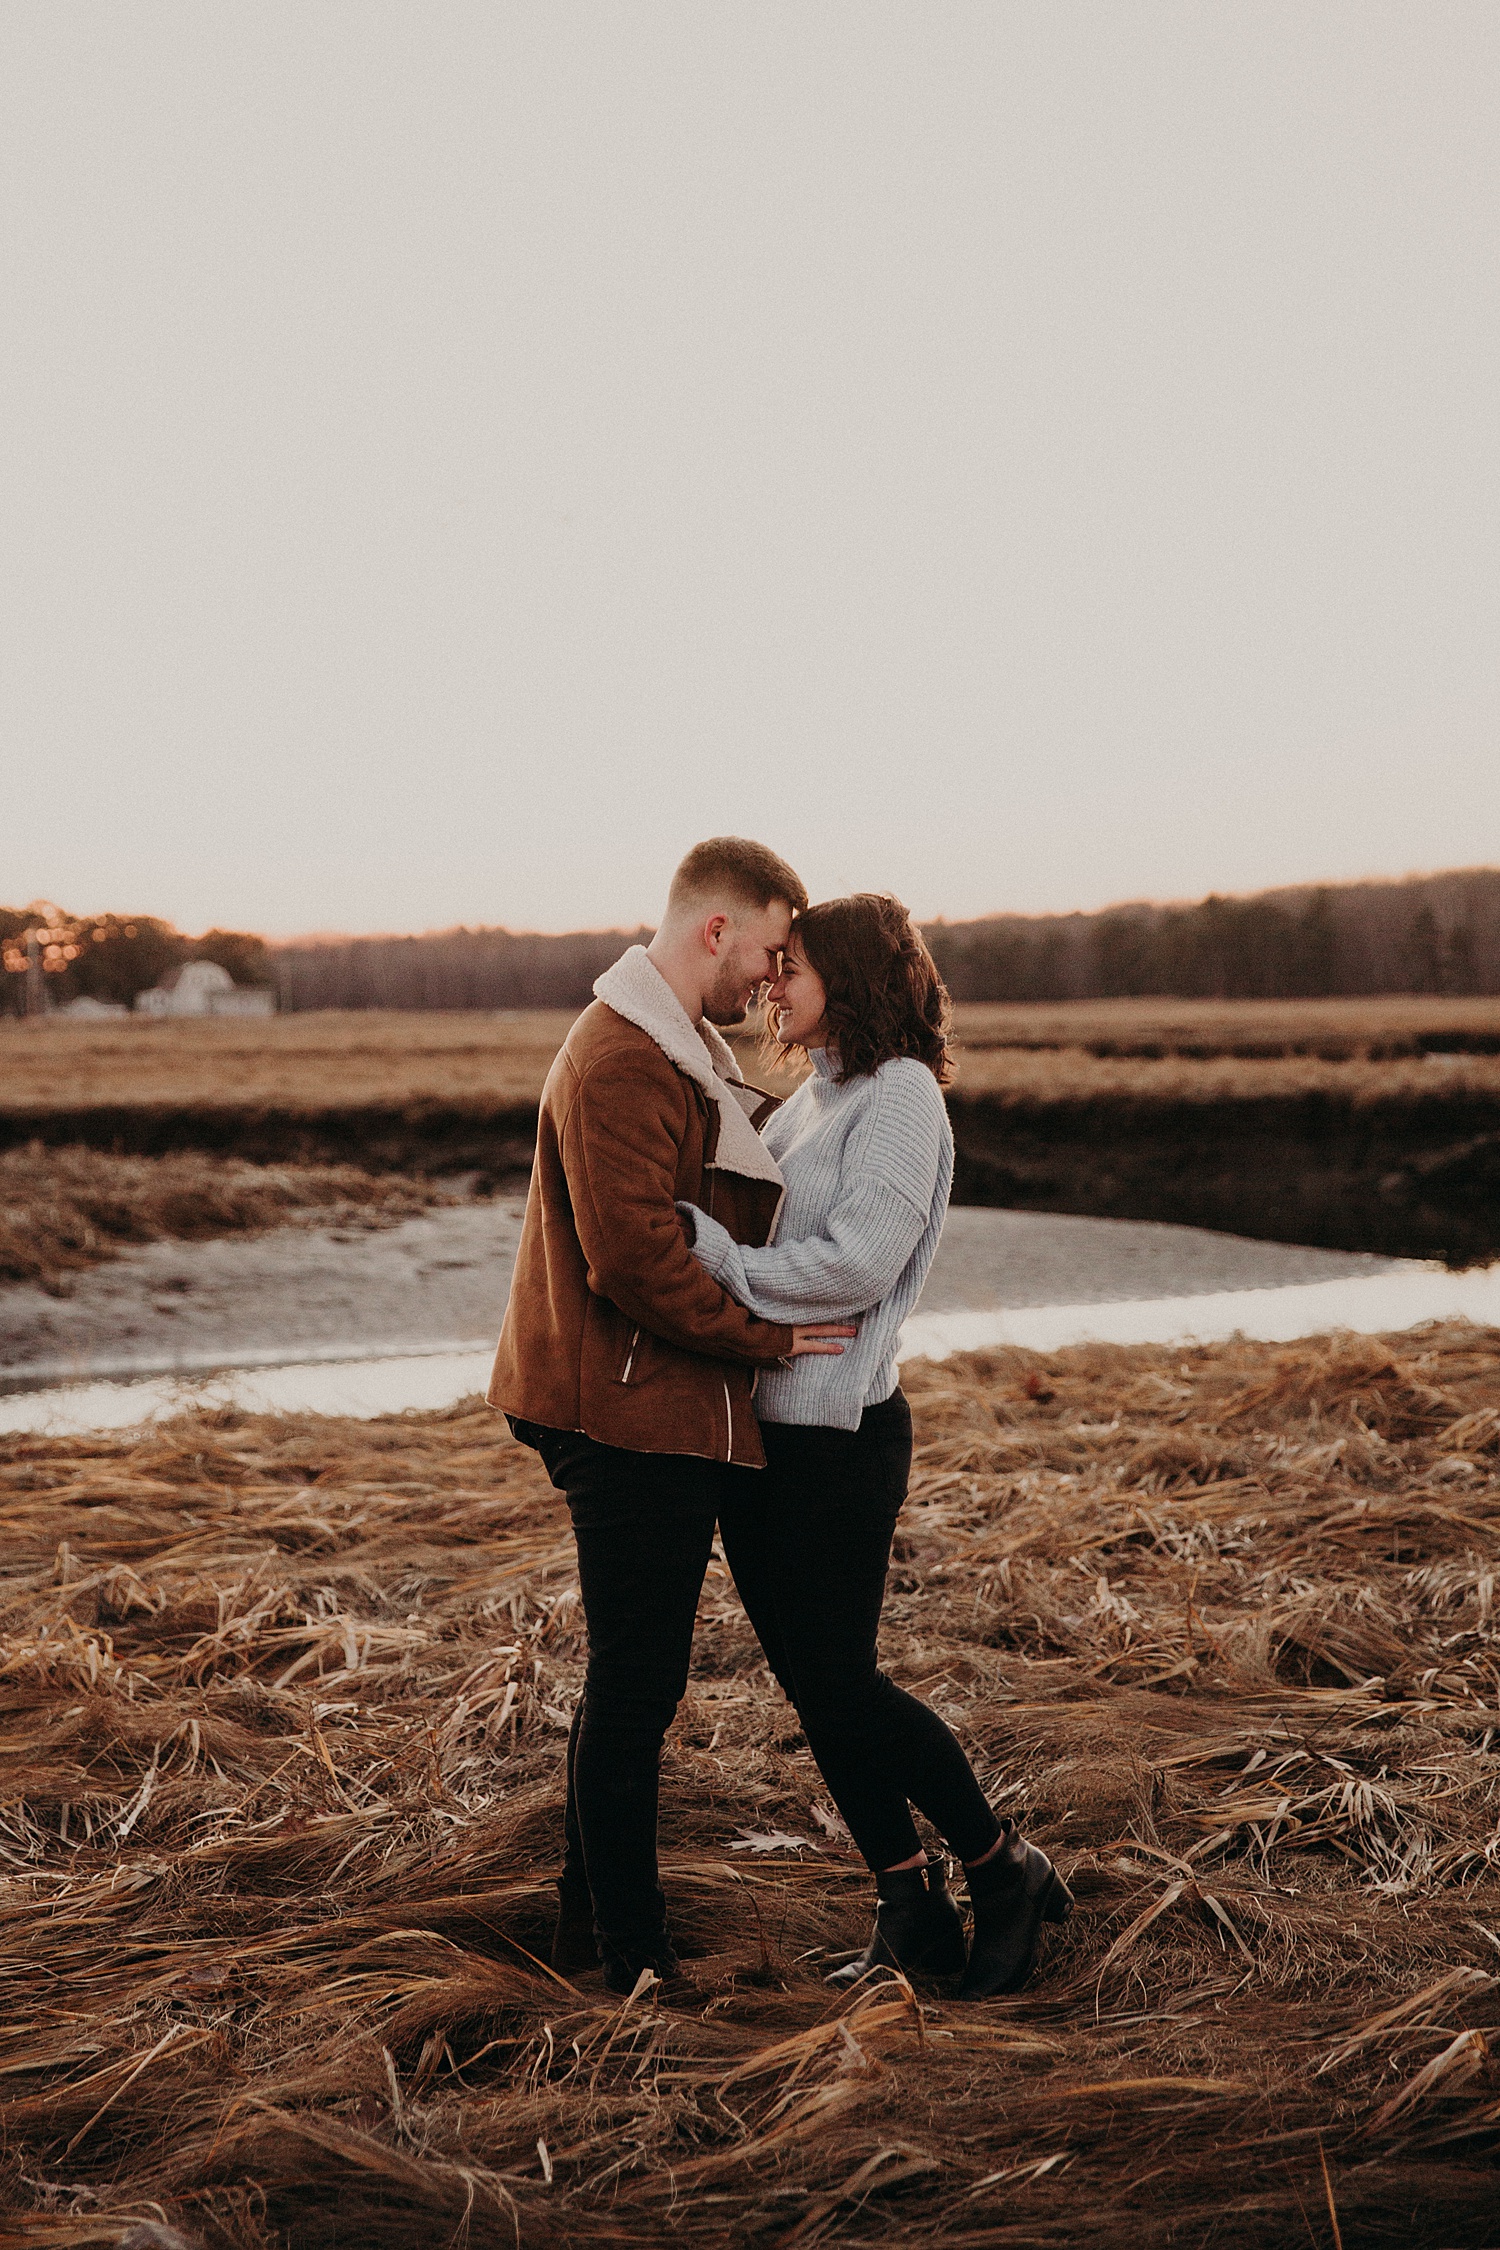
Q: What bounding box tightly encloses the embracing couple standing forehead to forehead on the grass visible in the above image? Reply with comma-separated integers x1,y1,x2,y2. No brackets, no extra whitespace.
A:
490,837,1070,1998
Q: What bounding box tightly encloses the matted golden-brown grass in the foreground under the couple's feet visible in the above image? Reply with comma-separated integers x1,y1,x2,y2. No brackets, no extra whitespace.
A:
0,1325,1500,2250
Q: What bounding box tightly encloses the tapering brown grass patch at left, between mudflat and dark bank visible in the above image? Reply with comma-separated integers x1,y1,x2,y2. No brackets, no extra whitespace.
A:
0,1148,454,1292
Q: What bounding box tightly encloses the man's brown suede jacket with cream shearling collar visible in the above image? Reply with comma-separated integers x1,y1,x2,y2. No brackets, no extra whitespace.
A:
488,947,792,1467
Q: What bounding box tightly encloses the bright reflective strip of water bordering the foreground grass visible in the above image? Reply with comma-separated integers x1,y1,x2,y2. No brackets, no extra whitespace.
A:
0,1262,1500,1433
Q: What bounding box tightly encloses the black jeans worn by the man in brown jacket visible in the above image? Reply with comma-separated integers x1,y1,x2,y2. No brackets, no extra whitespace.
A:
510,1422,728,1964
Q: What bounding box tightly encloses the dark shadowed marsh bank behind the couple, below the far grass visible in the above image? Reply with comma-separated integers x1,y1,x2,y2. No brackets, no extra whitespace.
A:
0,1085,1500,1265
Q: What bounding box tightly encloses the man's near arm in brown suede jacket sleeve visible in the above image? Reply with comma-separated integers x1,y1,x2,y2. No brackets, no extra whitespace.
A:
562,1055,792,1366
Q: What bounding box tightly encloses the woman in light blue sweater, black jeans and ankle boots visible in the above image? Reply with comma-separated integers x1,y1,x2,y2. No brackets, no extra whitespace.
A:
681,893,1073,1998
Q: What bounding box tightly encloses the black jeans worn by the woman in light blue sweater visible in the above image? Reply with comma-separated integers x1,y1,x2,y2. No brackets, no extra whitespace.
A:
720,1391,1001,1870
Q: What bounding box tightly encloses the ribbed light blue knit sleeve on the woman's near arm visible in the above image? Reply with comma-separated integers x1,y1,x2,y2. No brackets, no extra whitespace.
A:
684,1060,947,1323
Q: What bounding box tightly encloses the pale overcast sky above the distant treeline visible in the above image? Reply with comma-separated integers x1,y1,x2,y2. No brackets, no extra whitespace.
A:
0,0,1500,934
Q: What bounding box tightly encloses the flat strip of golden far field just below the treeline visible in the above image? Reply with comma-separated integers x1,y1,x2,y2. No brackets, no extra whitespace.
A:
0,997,1500,1112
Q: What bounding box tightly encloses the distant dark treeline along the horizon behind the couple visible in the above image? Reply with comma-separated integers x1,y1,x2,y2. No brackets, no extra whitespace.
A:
0,869,1500,1013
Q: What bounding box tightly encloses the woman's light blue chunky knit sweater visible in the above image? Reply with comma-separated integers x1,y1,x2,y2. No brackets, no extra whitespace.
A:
681,1049,954,1429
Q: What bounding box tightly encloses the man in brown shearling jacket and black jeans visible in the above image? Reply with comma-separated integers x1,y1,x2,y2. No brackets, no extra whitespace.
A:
490,837,850,1991
